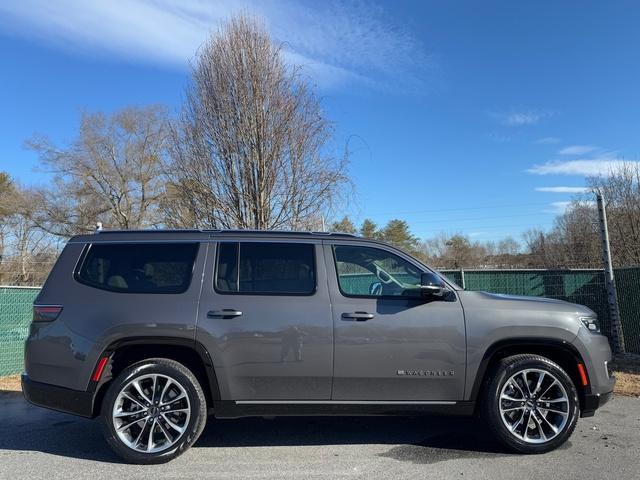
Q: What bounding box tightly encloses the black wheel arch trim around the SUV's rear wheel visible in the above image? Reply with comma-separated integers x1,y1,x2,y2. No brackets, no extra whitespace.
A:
90,337,220,417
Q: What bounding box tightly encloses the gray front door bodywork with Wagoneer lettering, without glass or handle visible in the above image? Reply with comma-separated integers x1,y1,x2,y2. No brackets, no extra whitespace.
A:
324,240,466,401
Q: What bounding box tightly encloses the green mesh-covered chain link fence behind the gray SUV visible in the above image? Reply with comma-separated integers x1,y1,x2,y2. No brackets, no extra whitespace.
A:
0,267,640,376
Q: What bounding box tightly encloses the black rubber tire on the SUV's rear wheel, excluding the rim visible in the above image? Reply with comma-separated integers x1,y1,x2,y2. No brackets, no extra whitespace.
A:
100,358,207,464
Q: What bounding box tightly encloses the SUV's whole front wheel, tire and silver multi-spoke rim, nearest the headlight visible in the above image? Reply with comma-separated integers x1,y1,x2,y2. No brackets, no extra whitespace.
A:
483,354,580,453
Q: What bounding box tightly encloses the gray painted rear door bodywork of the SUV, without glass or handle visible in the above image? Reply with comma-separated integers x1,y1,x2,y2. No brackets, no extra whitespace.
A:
197,237,333,401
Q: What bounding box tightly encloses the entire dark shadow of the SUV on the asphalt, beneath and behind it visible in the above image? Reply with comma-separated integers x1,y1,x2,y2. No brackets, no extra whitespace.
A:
0,392,506,463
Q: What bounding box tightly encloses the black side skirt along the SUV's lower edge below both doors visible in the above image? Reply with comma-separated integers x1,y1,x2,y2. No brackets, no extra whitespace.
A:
213,400,475,418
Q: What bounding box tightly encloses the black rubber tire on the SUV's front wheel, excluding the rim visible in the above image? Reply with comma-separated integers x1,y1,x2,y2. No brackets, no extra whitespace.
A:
481,354,580,454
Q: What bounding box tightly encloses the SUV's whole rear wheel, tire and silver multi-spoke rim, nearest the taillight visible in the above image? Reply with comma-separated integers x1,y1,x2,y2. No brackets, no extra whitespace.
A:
101,358,207,464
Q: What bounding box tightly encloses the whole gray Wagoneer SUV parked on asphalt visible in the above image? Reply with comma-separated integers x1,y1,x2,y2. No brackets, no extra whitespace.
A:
22,230,614,463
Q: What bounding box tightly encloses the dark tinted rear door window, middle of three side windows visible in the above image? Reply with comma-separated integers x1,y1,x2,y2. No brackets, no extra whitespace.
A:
216,242,316,295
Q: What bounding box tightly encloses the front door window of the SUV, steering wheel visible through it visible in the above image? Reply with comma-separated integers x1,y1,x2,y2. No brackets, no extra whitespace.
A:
334,246,422,297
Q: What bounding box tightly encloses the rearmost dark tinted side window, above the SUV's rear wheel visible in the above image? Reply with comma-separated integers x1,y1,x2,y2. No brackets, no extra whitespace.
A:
77,243,198,293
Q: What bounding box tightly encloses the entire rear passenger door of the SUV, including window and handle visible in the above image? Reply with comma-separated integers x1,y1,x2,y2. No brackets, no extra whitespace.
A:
197,238,333,402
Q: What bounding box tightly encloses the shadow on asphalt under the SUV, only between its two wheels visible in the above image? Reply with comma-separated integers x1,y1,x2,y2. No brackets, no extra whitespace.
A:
194,416,509,463
